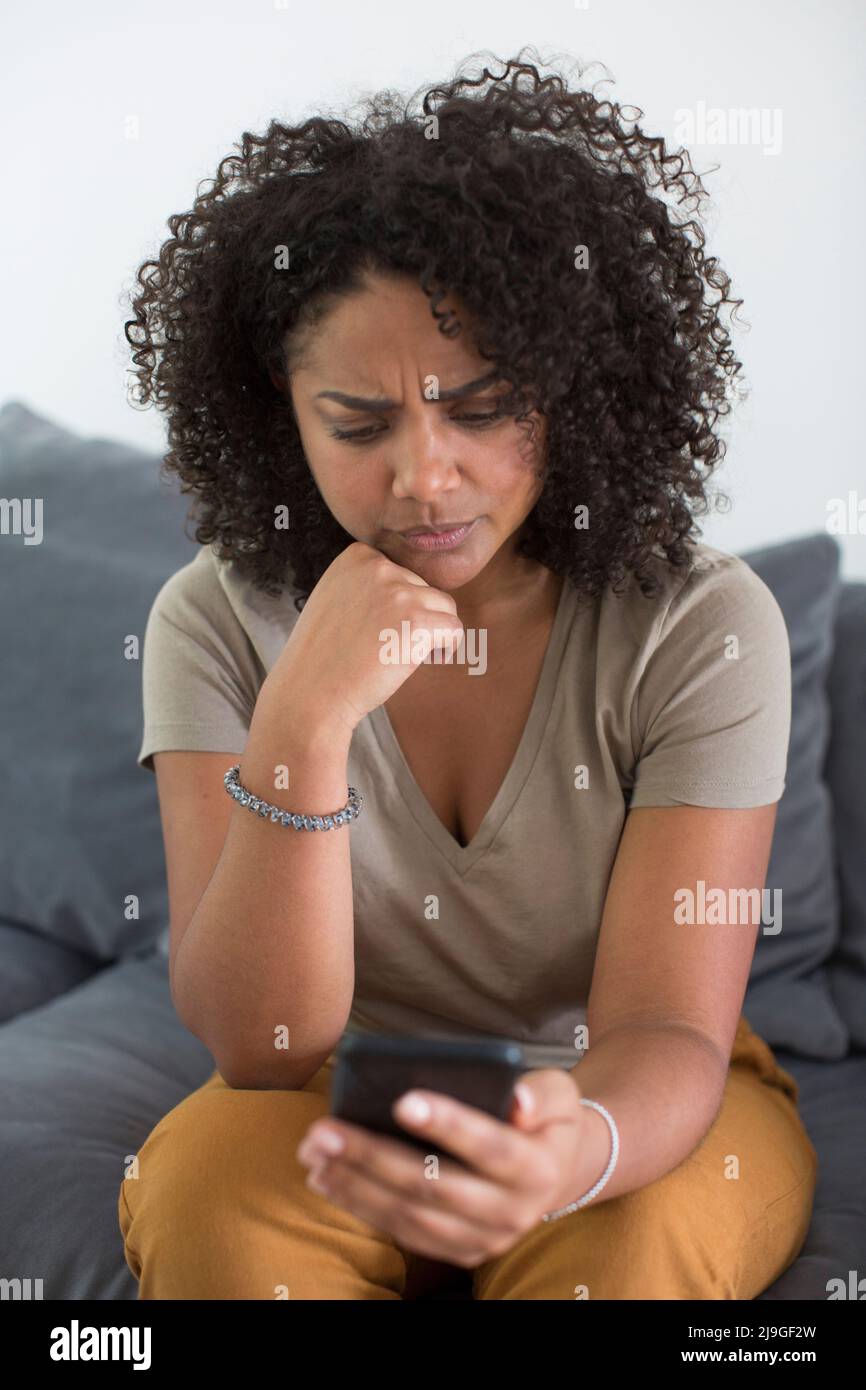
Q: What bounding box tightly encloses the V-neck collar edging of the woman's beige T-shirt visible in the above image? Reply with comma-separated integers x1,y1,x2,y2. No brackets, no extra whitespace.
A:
370,577,575,876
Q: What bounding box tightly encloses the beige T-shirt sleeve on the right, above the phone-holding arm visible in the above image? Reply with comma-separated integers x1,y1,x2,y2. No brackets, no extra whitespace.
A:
631,552,791,808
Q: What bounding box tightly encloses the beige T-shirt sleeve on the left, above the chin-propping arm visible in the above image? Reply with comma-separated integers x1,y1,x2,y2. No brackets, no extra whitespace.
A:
136,555,257,771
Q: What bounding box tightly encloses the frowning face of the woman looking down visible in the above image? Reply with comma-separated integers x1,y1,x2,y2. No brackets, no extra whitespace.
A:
289,275,544,602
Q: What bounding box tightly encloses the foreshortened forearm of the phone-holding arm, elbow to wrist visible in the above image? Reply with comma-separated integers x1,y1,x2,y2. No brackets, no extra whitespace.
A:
559,1024,728,1207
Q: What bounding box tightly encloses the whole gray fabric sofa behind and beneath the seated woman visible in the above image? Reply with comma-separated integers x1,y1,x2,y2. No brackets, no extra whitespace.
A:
0,402,866,1300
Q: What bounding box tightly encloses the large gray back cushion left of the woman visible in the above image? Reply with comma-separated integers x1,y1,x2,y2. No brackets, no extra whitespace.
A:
0,402,195,960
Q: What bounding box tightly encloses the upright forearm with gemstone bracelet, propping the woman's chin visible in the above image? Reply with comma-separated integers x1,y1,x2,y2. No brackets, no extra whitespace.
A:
174,667,354,1088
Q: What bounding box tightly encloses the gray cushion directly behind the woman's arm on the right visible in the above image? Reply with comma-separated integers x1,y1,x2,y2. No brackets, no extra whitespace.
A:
742,532,848,1061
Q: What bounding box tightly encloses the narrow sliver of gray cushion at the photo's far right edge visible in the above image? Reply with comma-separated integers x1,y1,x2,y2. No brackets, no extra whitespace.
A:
824,584,866,1052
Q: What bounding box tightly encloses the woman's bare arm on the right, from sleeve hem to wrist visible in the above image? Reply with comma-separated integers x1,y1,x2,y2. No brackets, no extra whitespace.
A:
562,803,776,1205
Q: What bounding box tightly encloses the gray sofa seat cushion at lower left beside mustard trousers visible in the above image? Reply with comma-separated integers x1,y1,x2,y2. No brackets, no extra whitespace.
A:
0,951,215,1300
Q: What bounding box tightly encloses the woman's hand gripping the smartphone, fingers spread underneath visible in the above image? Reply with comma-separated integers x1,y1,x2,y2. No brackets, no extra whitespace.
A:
297,1068,598,1269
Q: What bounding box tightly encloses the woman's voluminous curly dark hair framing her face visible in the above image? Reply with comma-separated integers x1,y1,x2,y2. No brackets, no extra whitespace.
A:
125,47,742,610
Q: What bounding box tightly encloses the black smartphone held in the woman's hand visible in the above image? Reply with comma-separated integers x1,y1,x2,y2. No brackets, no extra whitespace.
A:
331,1033,530,1163
